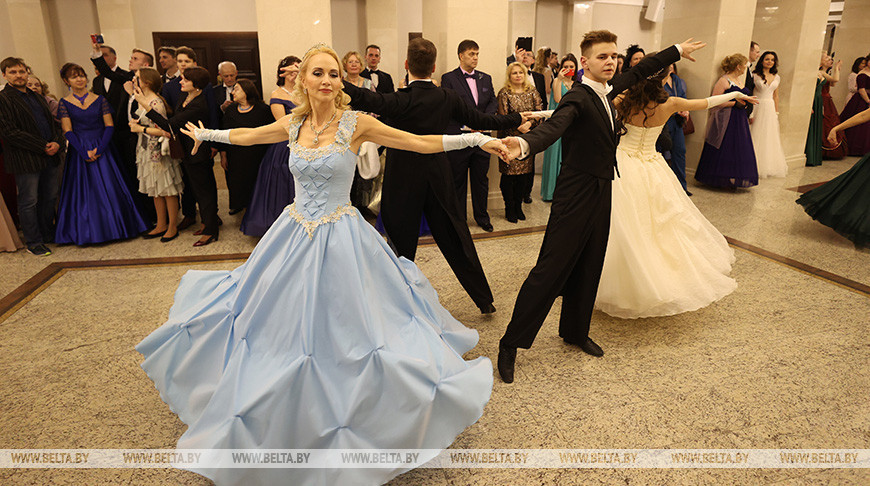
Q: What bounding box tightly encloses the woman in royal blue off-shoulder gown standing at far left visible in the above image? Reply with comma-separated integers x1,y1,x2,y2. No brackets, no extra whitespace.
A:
55,63,148,245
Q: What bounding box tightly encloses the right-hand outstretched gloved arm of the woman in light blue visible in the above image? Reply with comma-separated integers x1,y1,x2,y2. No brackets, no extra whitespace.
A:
351,114,506,155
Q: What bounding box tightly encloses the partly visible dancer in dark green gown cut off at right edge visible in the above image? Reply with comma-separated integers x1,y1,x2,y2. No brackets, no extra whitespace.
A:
797,104,870,247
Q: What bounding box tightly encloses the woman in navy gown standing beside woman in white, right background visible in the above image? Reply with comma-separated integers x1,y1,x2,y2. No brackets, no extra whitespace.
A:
695,54,758,188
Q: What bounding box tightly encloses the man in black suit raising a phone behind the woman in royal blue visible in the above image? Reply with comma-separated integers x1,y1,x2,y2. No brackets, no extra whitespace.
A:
91,44,156,221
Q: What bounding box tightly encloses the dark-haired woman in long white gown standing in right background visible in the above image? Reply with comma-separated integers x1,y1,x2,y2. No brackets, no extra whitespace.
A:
749,51,788,179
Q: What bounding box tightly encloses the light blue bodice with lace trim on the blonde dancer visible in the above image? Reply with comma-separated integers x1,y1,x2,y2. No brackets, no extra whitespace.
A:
287,110,359,236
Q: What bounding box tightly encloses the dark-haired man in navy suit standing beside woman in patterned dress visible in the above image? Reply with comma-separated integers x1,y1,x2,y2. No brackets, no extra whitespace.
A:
441,39,498,231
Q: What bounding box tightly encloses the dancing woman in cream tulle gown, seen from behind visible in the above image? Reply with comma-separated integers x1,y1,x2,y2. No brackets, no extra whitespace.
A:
595,69,757,319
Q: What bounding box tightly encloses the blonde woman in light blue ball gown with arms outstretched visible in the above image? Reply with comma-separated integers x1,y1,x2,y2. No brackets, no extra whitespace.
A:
136,46,504,485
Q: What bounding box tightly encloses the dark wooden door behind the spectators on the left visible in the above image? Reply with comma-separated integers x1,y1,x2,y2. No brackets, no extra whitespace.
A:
152,32,268,96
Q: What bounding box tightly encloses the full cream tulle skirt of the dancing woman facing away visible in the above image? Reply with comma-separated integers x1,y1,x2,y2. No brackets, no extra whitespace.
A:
595,149,737,319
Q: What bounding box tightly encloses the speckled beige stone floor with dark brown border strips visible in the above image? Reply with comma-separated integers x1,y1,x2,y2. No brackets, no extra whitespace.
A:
0,158,870,485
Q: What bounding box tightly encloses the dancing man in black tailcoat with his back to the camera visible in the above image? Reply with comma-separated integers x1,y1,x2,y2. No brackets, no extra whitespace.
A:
344,38,523,314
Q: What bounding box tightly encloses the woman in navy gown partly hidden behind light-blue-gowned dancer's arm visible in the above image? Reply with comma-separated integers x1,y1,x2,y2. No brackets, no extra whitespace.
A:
240,56,302,236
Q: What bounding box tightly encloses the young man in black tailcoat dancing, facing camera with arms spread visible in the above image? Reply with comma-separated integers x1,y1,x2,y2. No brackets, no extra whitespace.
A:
498,30,704,383
